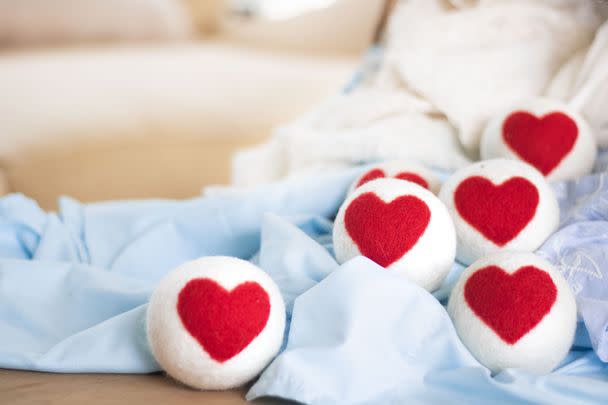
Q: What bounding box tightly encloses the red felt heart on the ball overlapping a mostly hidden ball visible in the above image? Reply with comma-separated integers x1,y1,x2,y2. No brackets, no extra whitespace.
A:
344,193,431,267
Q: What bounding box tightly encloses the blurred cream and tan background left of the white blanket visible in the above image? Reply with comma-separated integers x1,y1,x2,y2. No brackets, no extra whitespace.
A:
0,0,391,209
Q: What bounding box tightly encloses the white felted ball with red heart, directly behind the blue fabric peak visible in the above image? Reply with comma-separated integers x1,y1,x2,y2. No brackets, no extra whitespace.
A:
333,178,456,291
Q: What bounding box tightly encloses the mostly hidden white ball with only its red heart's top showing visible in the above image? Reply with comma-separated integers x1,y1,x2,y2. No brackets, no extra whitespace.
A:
349,160,441,194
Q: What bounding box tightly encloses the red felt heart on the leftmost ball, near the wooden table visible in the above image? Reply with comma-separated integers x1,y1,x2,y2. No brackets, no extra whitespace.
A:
177,278,270,363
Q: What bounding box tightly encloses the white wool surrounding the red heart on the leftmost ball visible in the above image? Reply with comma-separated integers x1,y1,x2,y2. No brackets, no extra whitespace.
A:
147,256,285,390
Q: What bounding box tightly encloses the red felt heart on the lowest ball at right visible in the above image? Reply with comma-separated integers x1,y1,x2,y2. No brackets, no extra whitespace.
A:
464,266,557,344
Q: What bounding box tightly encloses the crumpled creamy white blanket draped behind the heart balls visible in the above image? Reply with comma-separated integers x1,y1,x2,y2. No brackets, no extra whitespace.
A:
233,0,608,186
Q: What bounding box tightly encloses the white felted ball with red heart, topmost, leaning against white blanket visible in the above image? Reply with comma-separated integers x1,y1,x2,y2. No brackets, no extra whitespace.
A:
480,99,597,181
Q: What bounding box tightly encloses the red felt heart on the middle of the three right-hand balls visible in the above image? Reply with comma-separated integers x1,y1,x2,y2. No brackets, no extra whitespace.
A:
454,176,539,246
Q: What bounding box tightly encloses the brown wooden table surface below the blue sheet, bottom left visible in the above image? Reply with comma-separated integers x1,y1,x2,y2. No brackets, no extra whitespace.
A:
0,369,288,405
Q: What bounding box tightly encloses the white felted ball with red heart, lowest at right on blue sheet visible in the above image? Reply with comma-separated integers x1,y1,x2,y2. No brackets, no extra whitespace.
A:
448,252,576,373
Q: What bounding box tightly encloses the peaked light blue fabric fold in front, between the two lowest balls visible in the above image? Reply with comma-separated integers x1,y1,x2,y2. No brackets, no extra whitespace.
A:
248,258,608,404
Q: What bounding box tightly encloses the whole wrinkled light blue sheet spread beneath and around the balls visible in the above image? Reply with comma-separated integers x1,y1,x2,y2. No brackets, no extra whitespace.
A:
0,160,608,404
